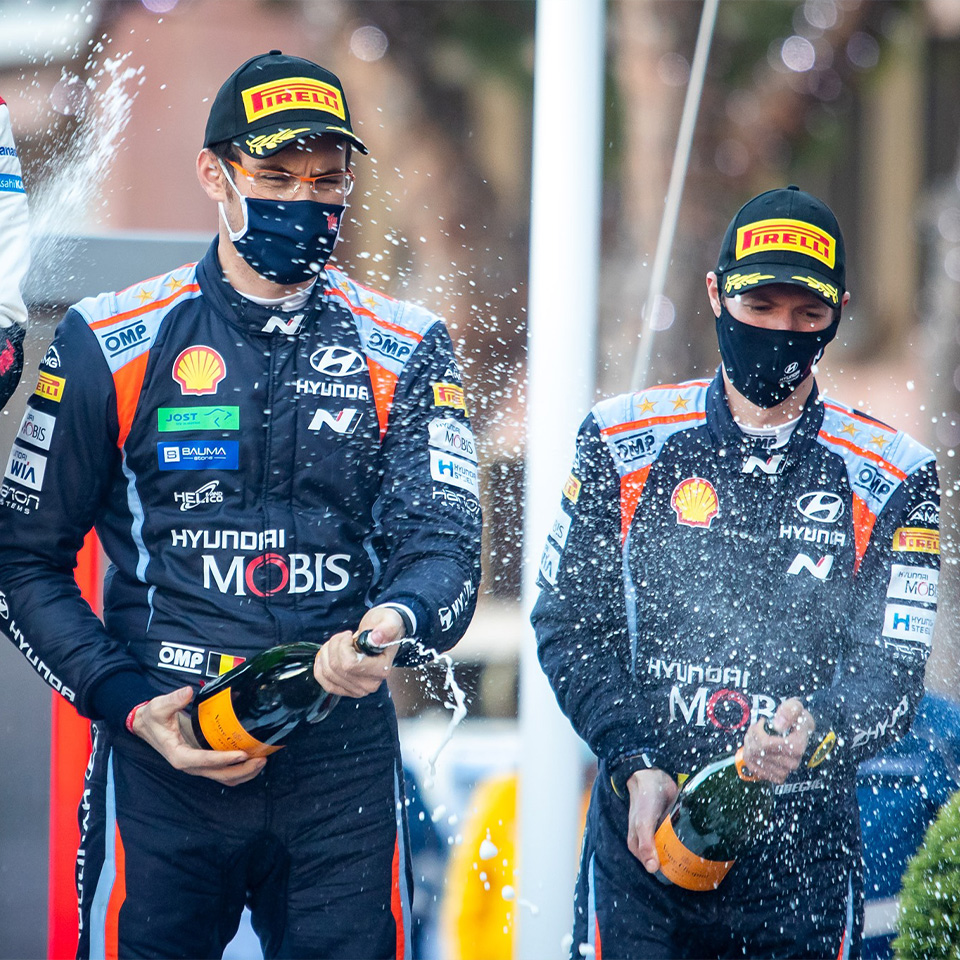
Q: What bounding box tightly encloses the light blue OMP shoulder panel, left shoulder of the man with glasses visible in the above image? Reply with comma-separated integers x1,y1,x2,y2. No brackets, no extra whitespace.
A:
73,263,201,373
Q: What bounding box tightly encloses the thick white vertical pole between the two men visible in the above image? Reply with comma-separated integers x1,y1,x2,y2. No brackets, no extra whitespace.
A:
514,0,605,960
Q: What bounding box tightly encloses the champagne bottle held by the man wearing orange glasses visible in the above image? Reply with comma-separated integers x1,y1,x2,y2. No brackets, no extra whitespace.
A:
188,630,383,757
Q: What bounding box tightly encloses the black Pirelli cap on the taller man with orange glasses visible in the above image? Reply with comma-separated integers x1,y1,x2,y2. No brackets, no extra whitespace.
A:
203,50,369,157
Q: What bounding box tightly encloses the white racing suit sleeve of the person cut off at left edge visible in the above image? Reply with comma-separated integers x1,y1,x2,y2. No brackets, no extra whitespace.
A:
0,97,30,408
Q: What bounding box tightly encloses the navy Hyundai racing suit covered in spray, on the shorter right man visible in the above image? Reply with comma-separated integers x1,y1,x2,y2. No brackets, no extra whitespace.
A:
532,373,939,958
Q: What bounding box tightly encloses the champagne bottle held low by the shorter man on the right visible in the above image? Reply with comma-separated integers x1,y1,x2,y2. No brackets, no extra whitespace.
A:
654,747,773,891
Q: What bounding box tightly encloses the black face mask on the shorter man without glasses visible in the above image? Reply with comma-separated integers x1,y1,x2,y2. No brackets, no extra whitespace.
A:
717,299,840,407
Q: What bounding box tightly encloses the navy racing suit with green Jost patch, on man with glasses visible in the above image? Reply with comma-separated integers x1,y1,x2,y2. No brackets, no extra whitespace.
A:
0,241,480,957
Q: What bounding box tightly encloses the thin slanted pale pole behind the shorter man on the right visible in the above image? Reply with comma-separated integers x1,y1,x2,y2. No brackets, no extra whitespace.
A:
630,0,719,390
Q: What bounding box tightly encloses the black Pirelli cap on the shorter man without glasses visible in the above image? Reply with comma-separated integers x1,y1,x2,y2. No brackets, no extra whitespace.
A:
717,185,846,309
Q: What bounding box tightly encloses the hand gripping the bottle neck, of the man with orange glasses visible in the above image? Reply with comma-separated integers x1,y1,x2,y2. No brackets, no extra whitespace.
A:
313,607,404,697
